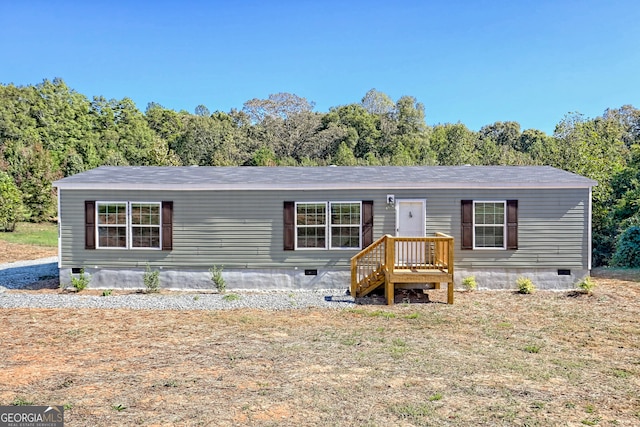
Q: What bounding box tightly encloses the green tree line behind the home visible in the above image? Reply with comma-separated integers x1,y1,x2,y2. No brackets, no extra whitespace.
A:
0,78,640,265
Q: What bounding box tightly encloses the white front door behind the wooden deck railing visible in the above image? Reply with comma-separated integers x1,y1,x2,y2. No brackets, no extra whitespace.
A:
396,199,427,266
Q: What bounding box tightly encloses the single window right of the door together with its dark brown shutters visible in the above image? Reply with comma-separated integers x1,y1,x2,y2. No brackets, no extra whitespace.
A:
460,200,518,249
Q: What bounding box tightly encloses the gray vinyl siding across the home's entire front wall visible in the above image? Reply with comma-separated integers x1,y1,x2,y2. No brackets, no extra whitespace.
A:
59,188,589,270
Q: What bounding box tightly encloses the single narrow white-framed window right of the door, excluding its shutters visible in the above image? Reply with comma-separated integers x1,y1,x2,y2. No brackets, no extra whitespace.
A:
473,202,506,248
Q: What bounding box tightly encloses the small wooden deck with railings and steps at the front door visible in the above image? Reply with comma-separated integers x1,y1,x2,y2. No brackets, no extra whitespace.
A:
351,233,454,304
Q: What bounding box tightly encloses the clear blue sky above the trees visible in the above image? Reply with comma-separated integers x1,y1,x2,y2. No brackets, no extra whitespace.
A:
0,0,640,133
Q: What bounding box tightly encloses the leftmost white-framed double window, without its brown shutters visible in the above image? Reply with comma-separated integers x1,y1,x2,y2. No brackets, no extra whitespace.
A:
96,202,161,249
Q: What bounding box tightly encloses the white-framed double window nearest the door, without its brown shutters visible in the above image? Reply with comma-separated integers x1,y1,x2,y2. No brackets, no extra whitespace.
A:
294,202,362,249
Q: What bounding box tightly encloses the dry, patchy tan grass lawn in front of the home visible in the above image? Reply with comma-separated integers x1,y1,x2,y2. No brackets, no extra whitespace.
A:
0,277,640,426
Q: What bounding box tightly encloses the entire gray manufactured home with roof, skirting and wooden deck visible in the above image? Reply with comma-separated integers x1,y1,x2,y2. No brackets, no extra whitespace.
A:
54,166,597,298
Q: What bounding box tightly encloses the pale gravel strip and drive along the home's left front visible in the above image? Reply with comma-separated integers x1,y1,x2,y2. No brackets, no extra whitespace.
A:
0,257,354,310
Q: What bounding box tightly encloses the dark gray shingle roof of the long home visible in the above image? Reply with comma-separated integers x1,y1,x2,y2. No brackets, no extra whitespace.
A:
54,166,597,190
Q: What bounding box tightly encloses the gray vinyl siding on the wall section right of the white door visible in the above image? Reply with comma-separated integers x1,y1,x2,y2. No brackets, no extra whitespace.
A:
427,189,589,269
